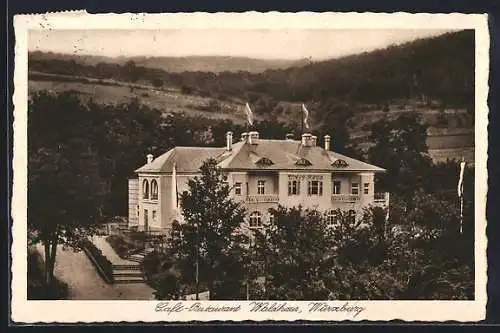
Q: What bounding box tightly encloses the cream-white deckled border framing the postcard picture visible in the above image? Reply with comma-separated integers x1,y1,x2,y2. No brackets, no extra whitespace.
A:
11,12,489,323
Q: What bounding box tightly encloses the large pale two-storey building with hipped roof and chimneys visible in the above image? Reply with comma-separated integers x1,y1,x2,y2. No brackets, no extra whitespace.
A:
129,132,389,233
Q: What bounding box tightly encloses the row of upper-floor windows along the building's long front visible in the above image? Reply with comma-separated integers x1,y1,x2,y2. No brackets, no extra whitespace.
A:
234,180,370,195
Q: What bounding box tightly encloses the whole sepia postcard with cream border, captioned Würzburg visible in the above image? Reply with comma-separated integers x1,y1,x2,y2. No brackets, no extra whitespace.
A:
11,11,489,323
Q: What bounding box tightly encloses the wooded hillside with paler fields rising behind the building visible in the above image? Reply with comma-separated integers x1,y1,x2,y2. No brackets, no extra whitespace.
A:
29,31,474,160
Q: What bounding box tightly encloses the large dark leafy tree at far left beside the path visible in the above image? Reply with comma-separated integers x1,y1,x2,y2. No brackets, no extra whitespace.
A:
28,93,104,285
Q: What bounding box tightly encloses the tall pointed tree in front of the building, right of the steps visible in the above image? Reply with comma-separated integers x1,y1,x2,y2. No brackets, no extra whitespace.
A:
169,159,248,299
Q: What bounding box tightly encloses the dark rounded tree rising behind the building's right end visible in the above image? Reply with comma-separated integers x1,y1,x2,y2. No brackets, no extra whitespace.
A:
368,113,431,204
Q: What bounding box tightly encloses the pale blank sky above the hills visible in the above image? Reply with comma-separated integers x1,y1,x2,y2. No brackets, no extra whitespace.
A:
28,29,458,60
